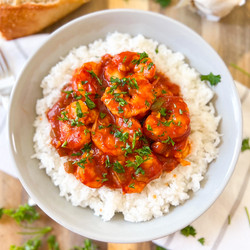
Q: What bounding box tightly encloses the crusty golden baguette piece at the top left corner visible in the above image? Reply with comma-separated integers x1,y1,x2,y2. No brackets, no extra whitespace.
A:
0,0,89,40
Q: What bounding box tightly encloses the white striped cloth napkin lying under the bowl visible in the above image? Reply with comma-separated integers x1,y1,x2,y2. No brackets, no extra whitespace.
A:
0,35,250,250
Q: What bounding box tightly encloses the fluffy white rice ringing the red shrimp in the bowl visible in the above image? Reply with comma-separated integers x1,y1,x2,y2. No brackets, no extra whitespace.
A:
34,33,220,222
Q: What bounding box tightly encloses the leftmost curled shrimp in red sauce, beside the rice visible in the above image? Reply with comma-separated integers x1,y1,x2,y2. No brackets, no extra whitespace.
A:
57,100,98,150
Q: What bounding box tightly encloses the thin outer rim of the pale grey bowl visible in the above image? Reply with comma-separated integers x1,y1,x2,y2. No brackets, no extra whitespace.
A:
8,9,242,243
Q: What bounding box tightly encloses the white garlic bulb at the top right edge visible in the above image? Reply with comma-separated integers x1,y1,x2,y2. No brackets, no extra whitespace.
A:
178,0,246,21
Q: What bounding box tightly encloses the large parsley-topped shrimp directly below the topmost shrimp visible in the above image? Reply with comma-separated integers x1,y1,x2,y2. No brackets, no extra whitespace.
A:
101,74,155,118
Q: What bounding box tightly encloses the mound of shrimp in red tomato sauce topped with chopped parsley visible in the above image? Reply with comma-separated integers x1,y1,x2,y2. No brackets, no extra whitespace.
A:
47,51,190,193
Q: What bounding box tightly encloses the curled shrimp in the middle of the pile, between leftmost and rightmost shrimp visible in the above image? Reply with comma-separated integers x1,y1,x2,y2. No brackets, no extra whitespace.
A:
92,115,142,156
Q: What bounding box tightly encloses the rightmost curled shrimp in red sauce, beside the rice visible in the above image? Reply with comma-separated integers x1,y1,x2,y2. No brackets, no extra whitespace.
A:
143,96,190,145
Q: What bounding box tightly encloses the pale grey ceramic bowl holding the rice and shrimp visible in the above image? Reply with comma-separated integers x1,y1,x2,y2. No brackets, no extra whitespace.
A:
9,10,242,243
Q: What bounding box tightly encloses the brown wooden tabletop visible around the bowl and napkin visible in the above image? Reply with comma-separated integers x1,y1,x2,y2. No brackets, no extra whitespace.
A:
0,0,250,250
